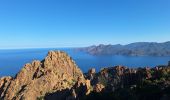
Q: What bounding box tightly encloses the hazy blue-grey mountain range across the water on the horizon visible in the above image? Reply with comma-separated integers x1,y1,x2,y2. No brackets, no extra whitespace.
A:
78,41,170,56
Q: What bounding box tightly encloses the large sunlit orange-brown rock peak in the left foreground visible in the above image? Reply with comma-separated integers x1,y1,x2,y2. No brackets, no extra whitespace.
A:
0,51,84,100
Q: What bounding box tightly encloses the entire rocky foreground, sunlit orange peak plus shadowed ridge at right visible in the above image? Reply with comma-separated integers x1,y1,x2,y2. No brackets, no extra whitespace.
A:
0,51,170,100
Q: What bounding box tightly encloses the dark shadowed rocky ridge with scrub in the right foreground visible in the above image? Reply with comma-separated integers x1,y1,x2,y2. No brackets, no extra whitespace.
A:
83,66,170,100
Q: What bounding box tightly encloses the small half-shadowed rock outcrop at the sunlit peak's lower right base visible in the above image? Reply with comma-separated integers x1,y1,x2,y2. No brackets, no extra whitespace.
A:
45,78,92,100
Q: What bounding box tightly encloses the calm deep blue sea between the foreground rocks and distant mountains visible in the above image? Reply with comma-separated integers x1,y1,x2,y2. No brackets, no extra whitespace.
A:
0,48,170,77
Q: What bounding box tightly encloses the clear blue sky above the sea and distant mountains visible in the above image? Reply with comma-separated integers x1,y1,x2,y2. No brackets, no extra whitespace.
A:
0,0,170,49
